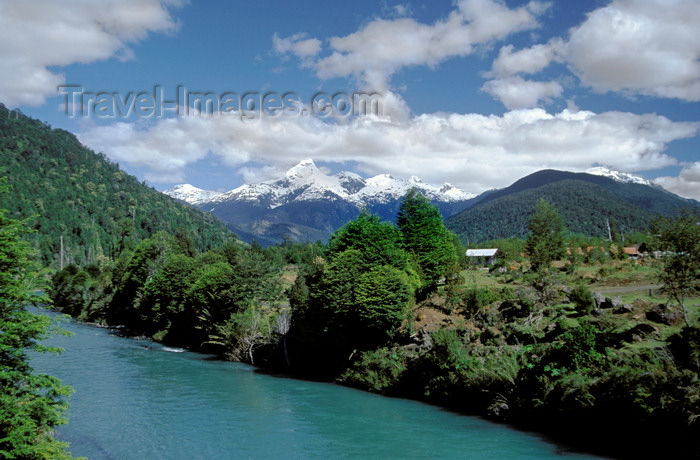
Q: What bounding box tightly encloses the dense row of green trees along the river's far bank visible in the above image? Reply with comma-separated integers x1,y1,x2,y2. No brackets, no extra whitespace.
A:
50,191,462,369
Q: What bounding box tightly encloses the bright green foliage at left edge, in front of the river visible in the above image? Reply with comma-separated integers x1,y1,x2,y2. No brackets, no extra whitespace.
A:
0,175,71,459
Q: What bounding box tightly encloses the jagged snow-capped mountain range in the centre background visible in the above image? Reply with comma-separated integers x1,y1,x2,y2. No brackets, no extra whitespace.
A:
164,160,475,244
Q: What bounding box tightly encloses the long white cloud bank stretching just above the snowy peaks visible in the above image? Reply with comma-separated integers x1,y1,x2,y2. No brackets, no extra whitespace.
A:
80,109,700,193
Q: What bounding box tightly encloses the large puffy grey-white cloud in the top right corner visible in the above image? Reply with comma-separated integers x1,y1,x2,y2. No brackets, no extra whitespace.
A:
567,0,700,101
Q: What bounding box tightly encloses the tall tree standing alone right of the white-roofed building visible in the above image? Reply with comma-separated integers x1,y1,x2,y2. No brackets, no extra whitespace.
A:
525,198,566,272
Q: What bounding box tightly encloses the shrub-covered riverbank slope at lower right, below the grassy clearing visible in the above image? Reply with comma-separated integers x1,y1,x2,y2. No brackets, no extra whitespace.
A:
282,286,700,458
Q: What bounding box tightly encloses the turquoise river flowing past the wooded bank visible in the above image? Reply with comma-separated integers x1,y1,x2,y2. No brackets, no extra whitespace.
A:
32,310,604,460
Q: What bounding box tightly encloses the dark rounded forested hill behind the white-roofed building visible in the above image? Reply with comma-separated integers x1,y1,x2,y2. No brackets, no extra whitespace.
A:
445,170,700,243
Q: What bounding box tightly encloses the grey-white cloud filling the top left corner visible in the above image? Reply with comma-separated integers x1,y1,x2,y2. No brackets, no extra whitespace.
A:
0,0,182,107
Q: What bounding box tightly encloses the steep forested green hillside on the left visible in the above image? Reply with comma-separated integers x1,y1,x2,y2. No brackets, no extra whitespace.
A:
0,104,234,267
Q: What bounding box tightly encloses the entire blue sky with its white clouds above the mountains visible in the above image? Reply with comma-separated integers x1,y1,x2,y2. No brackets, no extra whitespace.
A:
0,0,700,199
